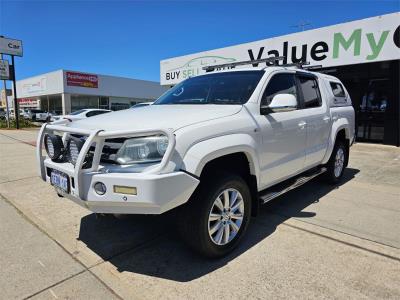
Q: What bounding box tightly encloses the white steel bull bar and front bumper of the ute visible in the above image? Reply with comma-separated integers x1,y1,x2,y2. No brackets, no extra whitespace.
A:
37,124,199,214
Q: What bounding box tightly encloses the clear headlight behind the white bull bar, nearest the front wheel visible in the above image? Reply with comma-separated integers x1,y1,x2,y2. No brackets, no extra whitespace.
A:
115,136,168,165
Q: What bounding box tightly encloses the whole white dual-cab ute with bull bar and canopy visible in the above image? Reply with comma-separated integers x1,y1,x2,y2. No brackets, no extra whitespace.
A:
37,59,354,257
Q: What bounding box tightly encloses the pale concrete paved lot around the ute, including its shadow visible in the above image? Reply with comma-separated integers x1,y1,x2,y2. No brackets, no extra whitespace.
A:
0,130,400,299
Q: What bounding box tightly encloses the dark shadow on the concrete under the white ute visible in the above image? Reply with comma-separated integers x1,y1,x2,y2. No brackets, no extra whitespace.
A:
78,168,359,282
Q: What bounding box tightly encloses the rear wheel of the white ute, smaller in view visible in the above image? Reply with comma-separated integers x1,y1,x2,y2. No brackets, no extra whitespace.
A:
326,141,349,184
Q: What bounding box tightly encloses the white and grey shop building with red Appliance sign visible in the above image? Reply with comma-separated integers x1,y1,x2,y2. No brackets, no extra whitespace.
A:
9,70,167,114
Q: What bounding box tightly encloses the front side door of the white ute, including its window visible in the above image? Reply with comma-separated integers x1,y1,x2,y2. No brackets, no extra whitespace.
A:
257,72,307,188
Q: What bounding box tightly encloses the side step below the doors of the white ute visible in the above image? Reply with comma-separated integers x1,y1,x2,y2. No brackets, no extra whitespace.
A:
260,167,326,204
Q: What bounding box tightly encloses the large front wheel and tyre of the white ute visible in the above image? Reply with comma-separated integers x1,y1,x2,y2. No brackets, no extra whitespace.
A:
179,173,251,257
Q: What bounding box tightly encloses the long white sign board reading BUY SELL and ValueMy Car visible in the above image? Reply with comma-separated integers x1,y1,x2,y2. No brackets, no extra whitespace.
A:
160,13,400,85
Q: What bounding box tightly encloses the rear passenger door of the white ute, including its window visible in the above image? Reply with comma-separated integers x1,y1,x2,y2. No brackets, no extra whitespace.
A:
296,72,331,169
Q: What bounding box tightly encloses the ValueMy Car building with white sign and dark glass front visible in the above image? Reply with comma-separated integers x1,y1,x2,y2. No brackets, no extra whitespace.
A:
160,13,400,146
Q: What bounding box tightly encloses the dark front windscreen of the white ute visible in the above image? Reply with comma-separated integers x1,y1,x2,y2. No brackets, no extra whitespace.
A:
154,71,264,105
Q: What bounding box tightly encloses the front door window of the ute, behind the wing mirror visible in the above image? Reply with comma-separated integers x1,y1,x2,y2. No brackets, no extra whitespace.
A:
261,74,297,106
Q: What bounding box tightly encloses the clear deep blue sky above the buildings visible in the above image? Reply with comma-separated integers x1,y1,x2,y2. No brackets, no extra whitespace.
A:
0,0,400,81
